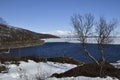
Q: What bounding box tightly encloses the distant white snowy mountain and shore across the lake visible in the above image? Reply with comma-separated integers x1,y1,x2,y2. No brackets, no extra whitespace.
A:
43,30,120,44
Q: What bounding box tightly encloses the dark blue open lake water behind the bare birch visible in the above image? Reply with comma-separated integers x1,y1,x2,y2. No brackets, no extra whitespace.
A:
5,42,120,62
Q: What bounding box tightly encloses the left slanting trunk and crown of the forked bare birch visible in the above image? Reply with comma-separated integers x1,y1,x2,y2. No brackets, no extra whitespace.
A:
71,14,99,65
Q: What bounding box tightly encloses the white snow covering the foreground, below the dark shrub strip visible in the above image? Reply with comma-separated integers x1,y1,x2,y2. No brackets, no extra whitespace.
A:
0,60,118,80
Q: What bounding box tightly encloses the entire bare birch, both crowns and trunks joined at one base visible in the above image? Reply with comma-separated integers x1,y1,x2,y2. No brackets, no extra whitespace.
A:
71,14,117,77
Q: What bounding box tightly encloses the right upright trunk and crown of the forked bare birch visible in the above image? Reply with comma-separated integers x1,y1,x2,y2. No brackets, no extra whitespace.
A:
95,17,117,62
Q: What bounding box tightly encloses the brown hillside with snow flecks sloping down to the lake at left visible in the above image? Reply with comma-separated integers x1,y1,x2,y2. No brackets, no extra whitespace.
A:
0,24,57,49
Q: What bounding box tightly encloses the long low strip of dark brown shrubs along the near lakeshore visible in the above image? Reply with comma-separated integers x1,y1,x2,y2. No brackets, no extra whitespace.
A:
0,56,81,65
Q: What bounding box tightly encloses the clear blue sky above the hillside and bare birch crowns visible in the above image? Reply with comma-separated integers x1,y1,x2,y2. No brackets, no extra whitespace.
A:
0,0,120,32
